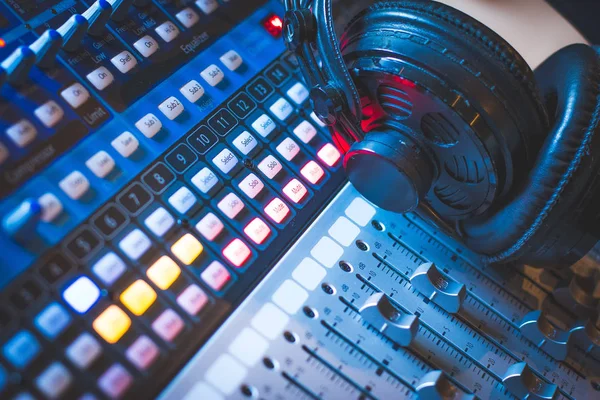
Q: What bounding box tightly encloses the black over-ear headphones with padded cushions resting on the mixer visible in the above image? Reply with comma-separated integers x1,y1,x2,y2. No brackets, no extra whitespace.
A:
284,0,600,268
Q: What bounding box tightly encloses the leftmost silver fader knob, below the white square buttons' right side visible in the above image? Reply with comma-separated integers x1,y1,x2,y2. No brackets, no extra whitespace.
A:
359,293,419,346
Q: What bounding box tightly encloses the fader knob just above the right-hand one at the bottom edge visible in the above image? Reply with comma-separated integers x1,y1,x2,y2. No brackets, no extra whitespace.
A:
520,310,570,361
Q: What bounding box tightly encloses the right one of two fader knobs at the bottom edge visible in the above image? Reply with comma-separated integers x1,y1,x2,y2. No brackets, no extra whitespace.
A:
502,362,558,400
